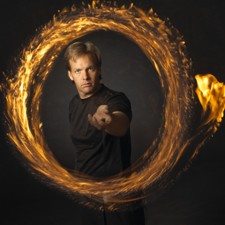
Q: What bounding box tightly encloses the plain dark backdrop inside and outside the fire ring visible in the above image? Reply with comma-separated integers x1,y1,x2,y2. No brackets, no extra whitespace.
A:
0,0,225,225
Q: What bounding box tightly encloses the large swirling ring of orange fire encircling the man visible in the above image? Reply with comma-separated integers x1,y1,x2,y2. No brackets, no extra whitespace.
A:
6,4,212,210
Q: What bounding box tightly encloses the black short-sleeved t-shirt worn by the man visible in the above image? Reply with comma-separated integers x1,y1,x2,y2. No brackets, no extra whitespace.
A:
69,85,132,177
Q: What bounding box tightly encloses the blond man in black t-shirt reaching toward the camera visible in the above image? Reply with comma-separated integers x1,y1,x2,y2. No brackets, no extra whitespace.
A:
65,42,143,225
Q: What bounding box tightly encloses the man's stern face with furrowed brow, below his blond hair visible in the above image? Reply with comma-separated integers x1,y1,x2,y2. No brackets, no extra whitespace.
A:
68,54,100,99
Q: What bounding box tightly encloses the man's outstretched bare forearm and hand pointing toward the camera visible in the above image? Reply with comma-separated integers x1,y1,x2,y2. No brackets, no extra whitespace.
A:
88,105,130,136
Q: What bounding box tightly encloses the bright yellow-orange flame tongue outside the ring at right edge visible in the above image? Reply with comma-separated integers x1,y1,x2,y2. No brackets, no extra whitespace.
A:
195,74,225,124
